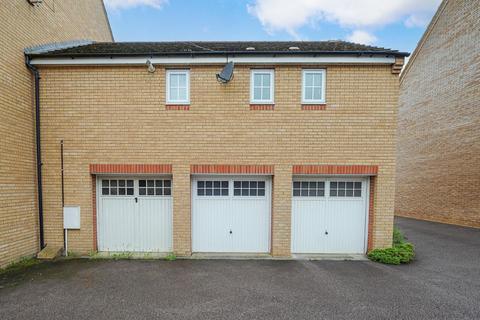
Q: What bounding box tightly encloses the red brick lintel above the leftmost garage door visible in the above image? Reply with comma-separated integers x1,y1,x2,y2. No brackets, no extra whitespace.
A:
90,164,172,174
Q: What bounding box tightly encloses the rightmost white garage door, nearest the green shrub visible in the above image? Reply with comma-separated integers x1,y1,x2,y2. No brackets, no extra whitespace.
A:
292,178,368,253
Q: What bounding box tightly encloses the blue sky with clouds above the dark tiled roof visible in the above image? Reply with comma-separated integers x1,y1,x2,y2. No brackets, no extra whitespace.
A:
105,0,440,52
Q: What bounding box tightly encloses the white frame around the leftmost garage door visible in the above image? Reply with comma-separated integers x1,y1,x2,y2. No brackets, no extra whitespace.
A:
94,173,174,253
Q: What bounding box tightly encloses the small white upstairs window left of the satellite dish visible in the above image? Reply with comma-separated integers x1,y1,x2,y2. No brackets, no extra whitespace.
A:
167,70,190,104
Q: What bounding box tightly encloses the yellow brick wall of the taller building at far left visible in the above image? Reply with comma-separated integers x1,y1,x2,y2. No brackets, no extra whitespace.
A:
0,0,112,267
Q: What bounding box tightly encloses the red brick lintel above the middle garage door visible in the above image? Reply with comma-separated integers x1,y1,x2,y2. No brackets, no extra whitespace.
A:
190,164,273,175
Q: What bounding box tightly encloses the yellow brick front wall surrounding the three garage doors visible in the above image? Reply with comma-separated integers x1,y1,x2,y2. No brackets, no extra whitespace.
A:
36,65,398,256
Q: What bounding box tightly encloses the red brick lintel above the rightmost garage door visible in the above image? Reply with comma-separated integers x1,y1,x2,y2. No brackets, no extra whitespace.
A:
292,165,378,176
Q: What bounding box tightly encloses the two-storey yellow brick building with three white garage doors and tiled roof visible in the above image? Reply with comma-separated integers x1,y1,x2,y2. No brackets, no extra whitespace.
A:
27,41,407,257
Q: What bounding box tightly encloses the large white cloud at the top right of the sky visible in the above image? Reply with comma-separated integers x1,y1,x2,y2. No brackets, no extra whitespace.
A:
247,0,441,41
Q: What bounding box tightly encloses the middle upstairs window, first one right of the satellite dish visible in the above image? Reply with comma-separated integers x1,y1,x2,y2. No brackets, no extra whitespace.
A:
250,70,274,104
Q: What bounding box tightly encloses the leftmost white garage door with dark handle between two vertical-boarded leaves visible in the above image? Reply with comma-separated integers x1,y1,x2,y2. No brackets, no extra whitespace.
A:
97,177,172,252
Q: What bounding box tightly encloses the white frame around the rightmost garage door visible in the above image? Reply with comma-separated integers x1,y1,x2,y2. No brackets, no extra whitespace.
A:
290,174,372,254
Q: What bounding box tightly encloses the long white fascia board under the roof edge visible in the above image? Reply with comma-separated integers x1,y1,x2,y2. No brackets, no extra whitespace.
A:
30,55,395,66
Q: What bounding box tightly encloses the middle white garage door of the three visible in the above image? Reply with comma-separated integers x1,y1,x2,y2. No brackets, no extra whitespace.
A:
192,176,271,253
